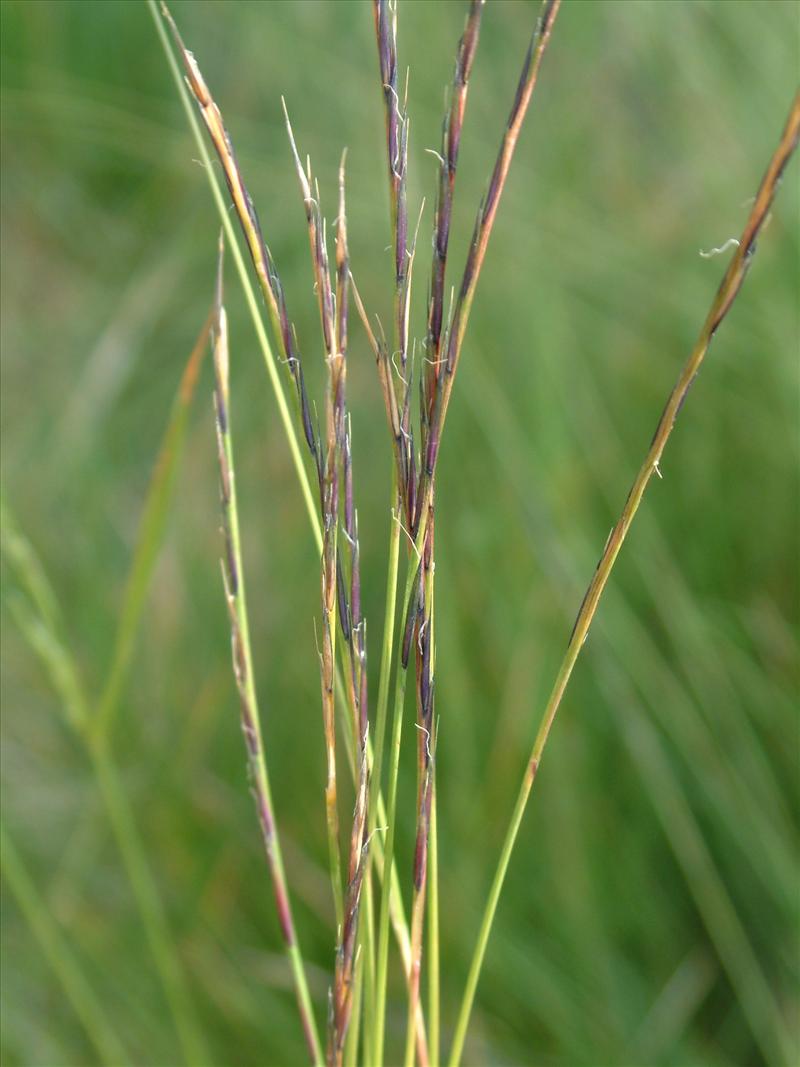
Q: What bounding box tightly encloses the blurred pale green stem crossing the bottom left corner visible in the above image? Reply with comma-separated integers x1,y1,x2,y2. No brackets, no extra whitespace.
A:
0,823,130,1067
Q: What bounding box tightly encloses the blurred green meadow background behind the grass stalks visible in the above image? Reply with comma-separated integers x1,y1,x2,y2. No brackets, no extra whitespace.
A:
0,0,800,1067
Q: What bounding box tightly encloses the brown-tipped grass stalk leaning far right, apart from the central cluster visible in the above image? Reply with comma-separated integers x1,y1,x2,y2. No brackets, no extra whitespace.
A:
450,89,800,1067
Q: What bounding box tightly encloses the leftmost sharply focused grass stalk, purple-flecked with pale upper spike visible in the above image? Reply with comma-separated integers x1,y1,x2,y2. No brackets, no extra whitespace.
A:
214,245,322,1064
